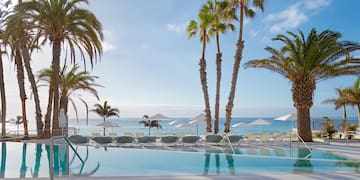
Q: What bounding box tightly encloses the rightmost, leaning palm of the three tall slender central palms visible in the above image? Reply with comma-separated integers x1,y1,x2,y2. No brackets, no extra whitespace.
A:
224,0,264,133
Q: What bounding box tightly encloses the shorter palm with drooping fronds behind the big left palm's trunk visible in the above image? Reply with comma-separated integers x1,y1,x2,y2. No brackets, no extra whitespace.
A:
38,64,100,124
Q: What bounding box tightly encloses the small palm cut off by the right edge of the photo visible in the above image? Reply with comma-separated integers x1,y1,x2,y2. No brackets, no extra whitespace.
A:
344,78,360,127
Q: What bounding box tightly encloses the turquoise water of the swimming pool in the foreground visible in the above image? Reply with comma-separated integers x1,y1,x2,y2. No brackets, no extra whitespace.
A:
0,142,360,178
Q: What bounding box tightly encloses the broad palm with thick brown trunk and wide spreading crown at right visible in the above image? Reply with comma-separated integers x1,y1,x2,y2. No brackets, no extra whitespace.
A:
245,28,360,141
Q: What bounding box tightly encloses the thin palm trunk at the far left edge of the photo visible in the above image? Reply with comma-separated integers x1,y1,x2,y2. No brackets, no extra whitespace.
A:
0,45,6,137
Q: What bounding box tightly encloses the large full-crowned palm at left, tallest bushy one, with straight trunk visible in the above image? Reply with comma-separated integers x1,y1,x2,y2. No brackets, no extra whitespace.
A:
23,0,103,135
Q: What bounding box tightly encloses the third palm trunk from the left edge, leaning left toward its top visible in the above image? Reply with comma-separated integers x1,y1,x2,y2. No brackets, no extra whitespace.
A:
22,45,44,137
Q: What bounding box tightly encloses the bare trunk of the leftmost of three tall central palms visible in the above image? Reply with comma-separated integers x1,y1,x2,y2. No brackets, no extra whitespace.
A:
199,30,211,132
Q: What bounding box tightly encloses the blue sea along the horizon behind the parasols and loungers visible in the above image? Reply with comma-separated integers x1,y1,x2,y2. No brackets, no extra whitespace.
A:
6,117,357,136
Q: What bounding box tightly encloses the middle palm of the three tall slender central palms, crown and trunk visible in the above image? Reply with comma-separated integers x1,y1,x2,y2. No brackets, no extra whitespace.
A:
203,0,237,134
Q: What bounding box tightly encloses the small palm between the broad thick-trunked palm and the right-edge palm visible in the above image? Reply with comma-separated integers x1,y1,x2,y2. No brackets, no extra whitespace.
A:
323,88,349,133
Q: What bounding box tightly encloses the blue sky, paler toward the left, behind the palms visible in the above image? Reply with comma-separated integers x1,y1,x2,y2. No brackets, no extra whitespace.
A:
4,0,360,121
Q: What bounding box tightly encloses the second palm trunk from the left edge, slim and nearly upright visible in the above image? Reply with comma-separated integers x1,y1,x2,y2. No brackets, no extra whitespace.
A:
15,50,29,139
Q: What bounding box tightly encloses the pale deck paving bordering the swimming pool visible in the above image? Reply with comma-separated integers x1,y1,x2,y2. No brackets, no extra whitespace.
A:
4,140,360,180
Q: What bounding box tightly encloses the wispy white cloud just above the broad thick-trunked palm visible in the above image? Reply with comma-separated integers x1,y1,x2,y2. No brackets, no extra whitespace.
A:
265,2,308,33
